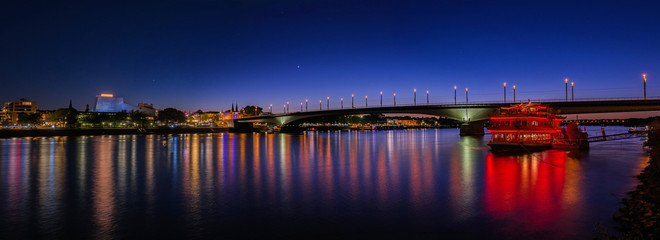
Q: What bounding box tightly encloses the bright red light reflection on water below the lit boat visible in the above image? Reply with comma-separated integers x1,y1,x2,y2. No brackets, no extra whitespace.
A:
484,151,579,237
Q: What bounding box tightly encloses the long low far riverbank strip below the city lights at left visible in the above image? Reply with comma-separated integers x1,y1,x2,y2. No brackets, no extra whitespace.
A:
0,128,228,138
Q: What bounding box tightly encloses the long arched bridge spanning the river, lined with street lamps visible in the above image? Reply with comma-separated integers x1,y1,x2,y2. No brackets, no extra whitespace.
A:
230,98,660,135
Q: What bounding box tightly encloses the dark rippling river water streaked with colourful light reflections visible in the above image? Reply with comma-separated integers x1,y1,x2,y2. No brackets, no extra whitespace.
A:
0,127,647,239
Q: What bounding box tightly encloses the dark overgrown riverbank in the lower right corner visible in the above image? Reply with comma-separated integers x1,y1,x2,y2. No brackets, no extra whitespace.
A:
614,128,660,239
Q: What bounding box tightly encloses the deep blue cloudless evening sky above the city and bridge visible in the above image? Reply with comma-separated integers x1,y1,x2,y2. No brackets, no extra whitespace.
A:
0,0,660,111
